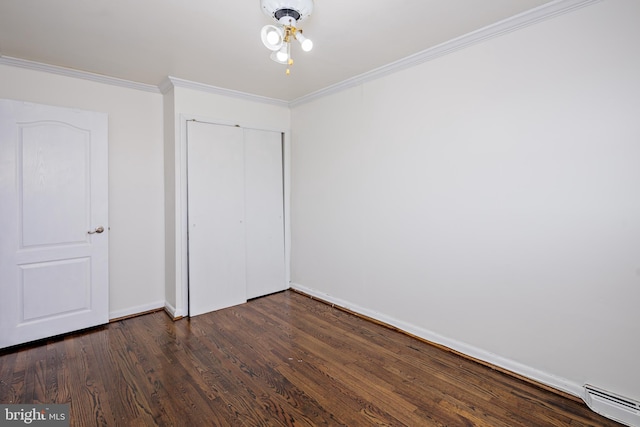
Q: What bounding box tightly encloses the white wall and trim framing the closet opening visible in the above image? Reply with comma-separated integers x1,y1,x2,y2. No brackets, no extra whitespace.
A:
164,82,291,317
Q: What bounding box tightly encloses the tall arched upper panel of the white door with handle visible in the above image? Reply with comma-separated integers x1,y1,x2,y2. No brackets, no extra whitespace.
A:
18,123,91,248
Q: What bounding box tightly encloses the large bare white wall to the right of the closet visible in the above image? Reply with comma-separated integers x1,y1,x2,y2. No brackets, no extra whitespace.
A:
291,0,640,400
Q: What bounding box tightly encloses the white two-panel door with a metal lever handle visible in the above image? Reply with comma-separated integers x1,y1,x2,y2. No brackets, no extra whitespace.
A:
0,100,109,348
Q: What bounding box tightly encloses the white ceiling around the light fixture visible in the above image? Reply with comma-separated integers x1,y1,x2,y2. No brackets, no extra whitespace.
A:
0,0,552,101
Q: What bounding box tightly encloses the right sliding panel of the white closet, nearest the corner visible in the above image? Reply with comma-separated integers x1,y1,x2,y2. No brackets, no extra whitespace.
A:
244,129,287,298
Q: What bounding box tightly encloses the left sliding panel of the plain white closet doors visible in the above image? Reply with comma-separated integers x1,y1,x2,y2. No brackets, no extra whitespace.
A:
187,121,247,316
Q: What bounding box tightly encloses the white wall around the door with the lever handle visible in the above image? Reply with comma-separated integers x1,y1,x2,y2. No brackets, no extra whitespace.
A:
0,65,164,318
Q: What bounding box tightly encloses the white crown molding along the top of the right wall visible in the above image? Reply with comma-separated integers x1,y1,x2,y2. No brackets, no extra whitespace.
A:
289,0,602,107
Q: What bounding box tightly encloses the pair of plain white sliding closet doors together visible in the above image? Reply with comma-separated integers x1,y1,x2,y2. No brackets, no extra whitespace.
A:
187,122,287,316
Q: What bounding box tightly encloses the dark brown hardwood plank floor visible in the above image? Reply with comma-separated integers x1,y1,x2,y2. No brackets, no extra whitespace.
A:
0,291,619,427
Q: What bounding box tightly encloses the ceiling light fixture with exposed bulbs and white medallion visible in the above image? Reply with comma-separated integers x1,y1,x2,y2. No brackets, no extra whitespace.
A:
260,0,313,75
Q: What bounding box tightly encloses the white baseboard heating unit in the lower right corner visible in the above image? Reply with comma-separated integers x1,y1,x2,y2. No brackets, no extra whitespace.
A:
584,384,640,427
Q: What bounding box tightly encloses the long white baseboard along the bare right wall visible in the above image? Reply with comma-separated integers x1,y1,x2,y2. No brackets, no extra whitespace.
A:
291,283,585,402
